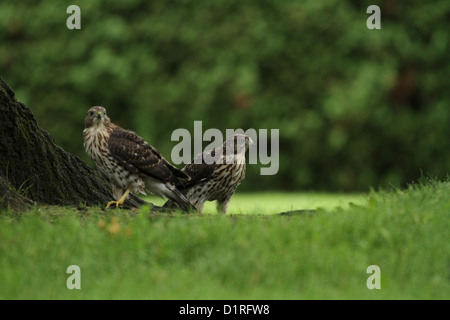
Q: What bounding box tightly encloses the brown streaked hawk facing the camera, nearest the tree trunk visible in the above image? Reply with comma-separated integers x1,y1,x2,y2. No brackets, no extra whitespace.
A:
83,106,192,210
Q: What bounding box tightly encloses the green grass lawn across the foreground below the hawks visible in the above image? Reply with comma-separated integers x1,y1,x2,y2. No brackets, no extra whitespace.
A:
0,180,450,299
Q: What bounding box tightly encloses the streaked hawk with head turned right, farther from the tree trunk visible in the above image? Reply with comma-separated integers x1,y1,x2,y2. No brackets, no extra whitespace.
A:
165,134,253,213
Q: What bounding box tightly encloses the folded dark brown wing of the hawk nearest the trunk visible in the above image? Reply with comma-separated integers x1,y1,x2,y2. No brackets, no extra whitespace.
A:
108,128,189,184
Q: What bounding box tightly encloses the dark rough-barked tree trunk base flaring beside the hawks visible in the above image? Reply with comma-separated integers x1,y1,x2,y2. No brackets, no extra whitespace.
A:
0,78,145,209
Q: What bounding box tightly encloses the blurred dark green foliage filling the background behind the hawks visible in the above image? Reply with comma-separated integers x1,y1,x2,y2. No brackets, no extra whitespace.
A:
0,0,450,190
